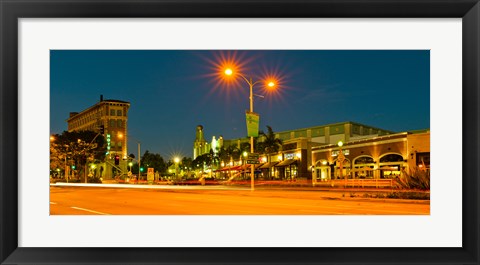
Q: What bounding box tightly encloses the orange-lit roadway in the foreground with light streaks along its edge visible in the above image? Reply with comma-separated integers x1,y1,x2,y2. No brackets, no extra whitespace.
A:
50,186,430,215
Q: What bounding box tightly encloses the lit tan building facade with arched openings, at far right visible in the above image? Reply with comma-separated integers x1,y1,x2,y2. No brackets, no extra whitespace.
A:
312,132,430,178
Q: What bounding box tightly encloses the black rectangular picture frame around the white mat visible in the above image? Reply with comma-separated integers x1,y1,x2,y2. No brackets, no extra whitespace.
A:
0,0,480,264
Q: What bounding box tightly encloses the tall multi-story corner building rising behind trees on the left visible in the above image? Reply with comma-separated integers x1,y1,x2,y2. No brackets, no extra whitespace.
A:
67,95,130,179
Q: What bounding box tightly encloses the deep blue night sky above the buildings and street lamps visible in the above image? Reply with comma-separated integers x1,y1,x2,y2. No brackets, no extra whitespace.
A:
50,50,430,159
